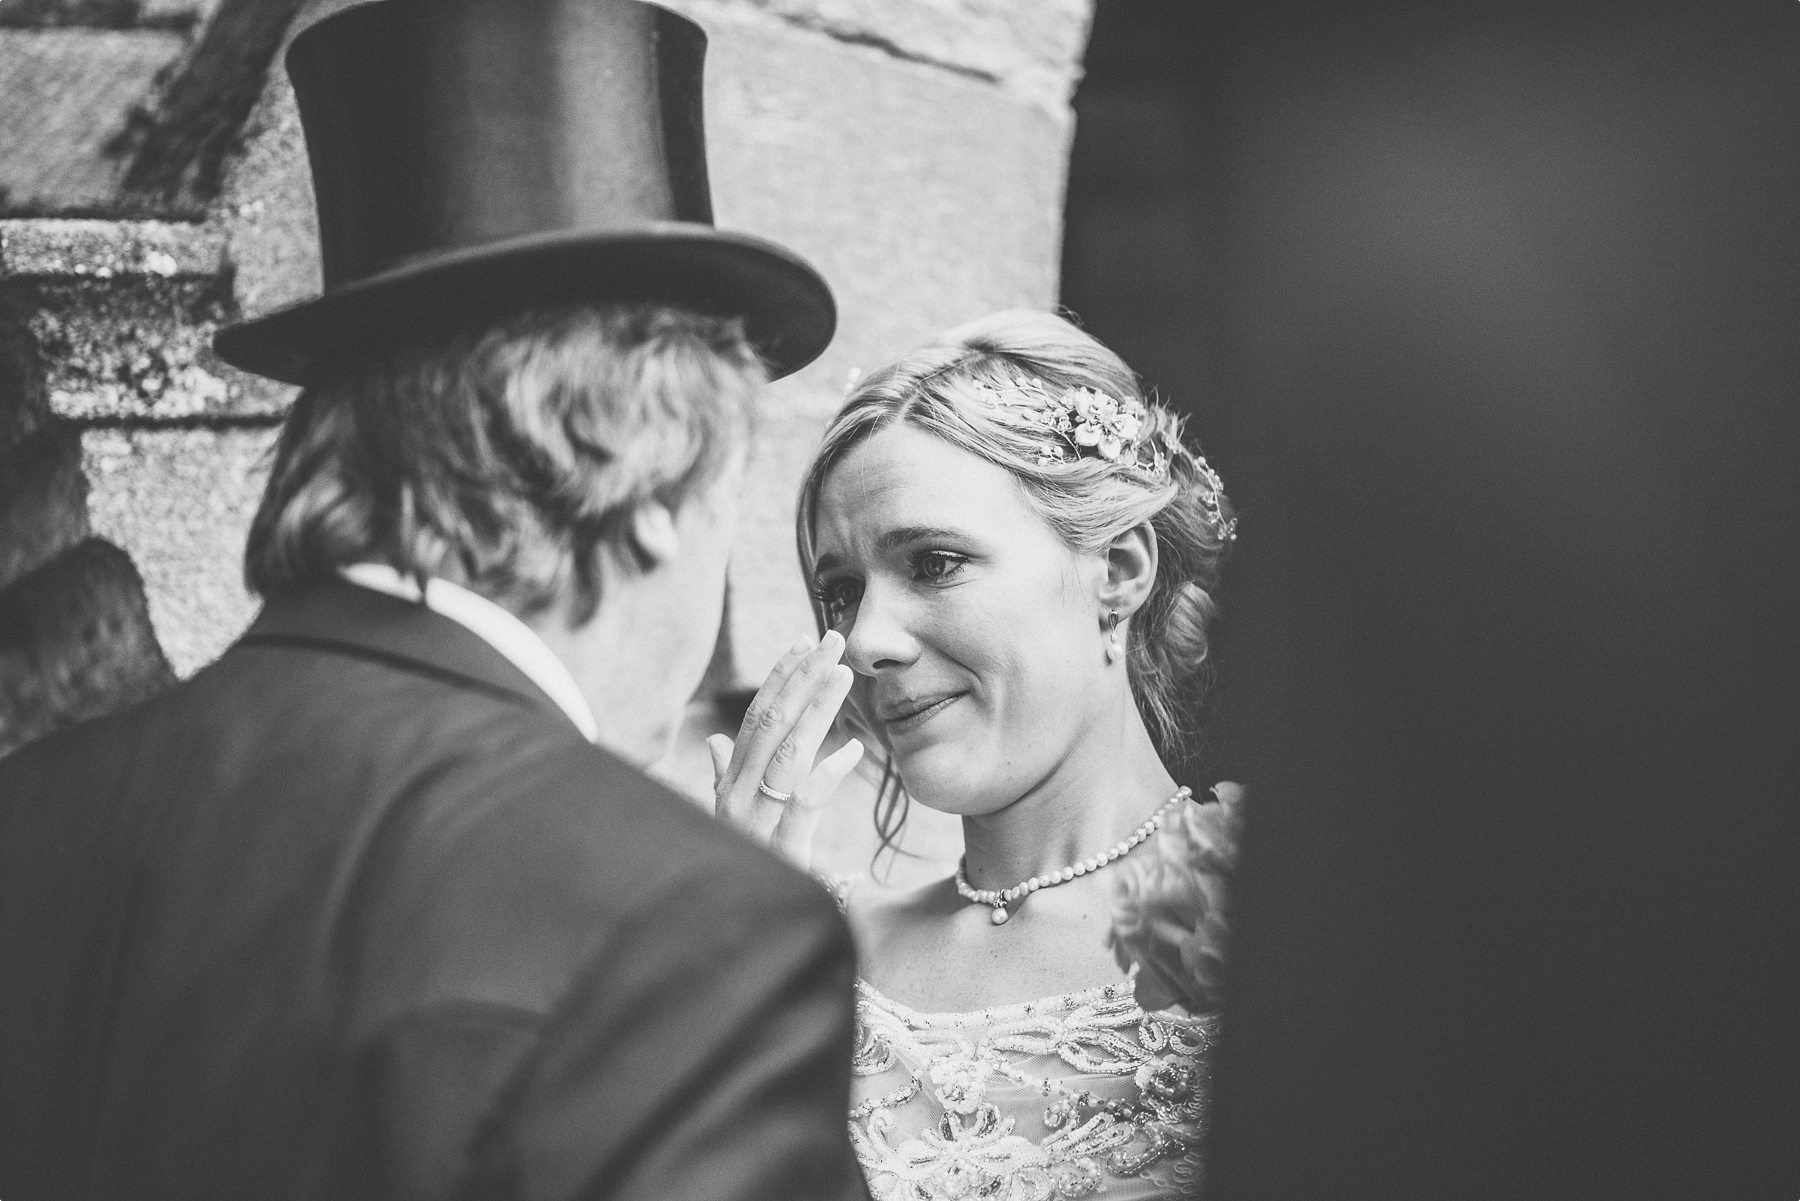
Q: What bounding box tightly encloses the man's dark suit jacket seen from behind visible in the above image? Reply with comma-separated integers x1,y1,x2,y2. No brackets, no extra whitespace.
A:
0,583,864,1201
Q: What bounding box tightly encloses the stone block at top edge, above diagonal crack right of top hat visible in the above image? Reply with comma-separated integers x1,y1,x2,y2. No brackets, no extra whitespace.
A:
670,0,1093,117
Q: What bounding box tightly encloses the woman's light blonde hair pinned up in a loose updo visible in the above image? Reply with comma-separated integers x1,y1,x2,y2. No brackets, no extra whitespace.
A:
796,310,1237,860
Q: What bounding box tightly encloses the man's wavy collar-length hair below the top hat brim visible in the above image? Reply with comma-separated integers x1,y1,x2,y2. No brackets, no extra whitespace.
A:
245,304,769,621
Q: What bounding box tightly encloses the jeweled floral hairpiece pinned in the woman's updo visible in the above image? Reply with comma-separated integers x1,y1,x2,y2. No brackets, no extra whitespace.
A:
972,375,1237,542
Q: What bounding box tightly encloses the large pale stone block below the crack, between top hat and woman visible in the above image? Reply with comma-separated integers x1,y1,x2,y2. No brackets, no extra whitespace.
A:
687,9,1071,688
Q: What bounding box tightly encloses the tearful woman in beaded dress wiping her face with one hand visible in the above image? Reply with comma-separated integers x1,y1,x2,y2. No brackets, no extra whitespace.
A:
711,312,1235,1201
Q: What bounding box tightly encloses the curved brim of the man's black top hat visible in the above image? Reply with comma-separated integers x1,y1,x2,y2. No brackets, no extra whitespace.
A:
212,221,837,385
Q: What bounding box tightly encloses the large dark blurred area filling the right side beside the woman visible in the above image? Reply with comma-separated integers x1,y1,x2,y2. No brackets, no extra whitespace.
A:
1066,0,1800,1201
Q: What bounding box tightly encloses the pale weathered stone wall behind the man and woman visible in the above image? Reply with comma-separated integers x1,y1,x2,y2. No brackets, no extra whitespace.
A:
0,0,1091,875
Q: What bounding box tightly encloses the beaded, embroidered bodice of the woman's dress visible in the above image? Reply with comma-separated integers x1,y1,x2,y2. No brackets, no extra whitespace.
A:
850,981,1217,1201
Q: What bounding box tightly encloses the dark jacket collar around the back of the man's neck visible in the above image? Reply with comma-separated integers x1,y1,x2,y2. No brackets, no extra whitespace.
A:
238,580,572,726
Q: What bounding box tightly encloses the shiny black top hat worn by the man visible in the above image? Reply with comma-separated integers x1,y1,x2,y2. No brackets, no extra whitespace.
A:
212,0,837,384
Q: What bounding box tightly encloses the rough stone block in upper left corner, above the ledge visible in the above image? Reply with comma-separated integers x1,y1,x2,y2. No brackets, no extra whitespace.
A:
0,29,185,216
